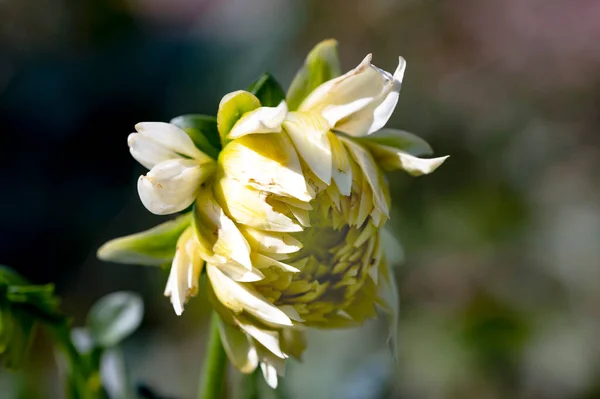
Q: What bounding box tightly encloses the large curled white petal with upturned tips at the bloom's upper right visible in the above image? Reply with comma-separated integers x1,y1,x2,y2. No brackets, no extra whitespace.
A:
299,54,406,136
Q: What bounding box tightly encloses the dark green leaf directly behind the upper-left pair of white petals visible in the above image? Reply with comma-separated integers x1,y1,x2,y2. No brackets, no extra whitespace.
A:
171,114,221,159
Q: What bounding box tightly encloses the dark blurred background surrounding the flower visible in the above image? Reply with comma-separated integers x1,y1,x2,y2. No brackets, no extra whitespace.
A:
0,0,600,399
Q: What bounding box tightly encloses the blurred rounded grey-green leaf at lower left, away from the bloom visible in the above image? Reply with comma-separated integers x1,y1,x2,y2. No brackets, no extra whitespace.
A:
87,291,144,348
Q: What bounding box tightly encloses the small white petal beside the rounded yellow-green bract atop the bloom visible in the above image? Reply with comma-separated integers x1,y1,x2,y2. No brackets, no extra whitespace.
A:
227,101,288,139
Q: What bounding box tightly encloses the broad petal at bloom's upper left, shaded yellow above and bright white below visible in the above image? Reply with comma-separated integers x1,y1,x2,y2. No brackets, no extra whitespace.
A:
220,134,312,202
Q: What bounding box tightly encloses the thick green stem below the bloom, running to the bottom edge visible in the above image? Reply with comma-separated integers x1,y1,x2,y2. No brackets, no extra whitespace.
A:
198,312,227,399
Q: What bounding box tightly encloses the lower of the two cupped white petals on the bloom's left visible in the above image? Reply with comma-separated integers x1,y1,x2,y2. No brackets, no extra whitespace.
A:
138,158,214,215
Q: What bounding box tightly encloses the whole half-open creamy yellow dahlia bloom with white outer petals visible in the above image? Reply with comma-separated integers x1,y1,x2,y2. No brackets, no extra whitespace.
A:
99,40,446,387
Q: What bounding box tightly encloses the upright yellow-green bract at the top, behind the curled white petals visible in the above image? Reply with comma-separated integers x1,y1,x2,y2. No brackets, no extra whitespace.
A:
287,39,341,111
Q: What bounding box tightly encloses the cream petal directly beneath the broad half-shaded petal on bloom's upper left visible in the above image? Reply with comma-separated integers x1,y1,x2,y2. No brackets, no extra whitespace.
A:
215,177,302,233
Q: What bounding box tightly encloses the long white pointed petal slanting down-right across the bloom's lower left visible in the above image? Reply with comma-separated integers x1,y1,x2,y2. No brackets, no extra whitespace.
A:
206,265,292,326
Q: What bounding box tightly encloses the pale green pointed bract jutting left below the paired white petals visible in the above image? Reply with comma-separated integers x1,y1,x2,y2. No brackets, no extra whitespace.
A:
97,213,191,266
